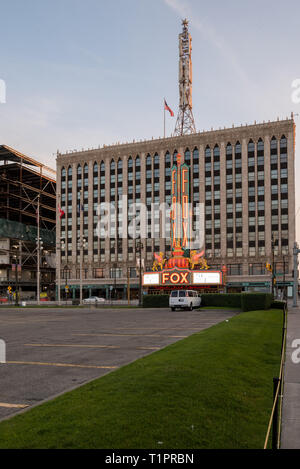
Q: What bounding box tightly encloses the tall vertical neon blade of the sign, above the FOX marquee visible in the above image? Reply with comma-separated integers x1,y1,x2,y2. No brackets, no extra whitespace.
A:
171,153,191,249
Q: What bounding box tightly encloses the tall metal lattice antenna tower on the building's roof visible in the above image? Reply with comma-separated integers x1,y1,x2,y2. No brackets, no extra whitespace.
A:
174,19,196,135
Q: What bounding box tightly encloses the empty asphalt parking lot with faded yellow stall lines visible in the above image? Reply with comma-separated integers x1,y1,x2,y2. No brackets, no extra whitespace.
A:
0,308,236,419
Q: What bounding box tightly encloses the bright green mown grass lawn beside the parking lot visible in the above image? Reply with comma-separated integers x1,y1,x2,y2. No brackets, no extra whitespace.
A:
0,310,282,449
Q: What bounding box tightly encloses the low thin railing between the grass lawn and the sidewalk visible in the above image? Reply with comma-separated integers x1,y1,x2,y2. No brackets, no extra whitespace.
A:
264,302,288,449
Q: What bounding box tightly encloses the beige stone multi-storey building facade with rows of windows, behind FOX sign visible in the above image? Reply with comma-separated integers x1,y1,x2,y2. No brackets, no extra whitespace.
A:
56,119,295,297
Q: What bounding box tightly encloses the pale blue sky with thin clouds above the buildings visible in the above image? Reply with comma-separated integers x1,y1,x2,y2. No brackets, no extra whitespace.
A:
0,0,300,243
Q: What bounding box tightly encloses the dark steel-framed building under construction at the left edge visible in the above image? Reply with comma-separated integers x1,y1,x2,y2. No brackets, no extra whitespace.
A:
0,145,56,301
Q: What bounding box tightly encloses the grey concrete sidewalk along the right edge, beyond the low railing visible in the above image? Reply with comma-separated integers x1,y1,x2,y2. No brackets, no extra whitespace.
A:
281,300,300,449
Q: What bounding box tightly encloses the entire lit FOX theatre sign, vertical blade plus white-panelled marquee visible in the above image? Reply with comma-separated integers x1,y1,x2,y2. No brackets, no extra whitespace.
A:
143,154,226,294
